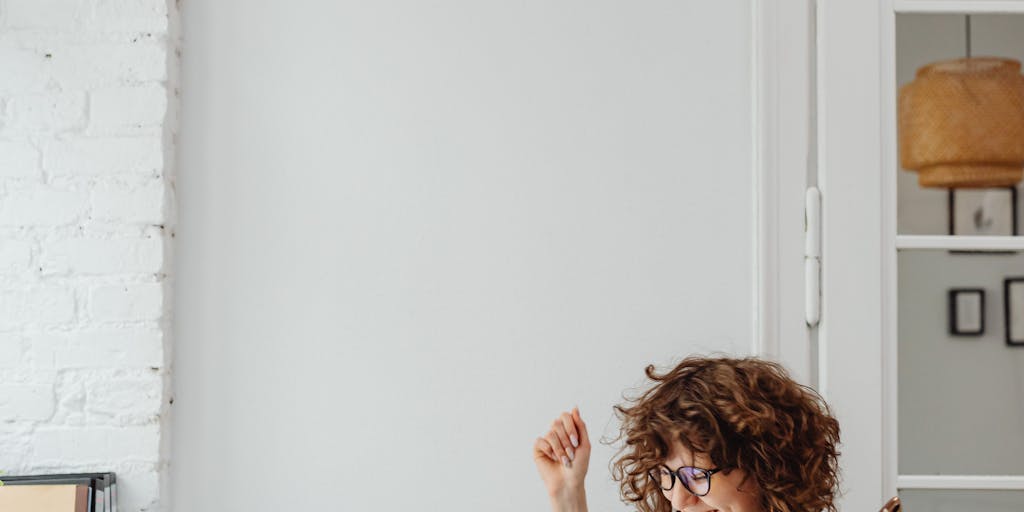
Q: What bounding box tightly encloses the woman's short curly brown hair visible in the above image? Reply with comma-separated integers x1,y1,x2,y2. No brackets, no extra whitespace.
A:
611,357,839,512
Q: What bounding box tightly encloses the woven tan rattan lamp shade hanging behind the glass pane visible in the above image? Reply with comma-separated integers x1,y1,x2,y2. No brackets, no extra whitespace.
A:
899,57,1024,188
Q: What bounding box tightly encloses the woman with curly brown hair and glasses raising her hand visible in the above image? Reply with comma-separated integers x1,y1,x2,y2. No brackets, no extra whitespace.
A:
534,357,839,512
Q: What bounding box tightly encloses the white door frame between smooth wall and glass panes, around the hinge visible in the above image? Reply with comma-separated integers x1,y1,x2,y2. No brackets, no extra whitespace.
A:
754,0,896,510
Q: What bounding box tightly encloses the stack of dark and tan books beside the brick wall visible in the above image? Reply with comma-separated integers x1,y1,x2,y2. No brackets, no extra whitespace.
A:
0,473,118,512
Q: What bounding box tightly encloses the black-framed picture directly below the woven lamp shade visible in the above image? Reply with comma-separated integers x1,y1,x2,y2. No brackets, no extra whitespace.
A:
948,186,1019,237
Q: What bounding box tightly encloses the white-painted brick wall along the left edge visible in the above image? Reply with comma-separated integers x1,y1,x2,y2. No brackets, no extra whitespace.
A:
0,0,180,511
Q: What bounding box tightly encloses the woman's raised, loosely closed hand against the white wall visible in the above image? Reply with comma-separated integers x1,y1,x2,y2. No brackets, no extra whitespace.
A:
534,408,590,508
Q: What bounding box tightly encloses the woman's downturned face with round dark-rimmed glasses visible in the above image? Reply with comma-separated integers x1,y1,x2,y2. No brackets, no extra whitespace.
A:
662,441,764,512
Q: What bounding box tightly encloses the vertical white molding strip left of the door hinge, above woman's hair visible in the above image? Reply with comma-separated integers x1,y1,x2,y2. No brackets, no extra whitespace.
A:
752,0,814,384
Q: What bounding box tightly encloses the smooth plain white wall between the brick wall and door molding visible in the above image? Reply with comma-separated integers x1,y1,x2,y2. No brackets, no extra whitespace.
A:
172,0,754,511
